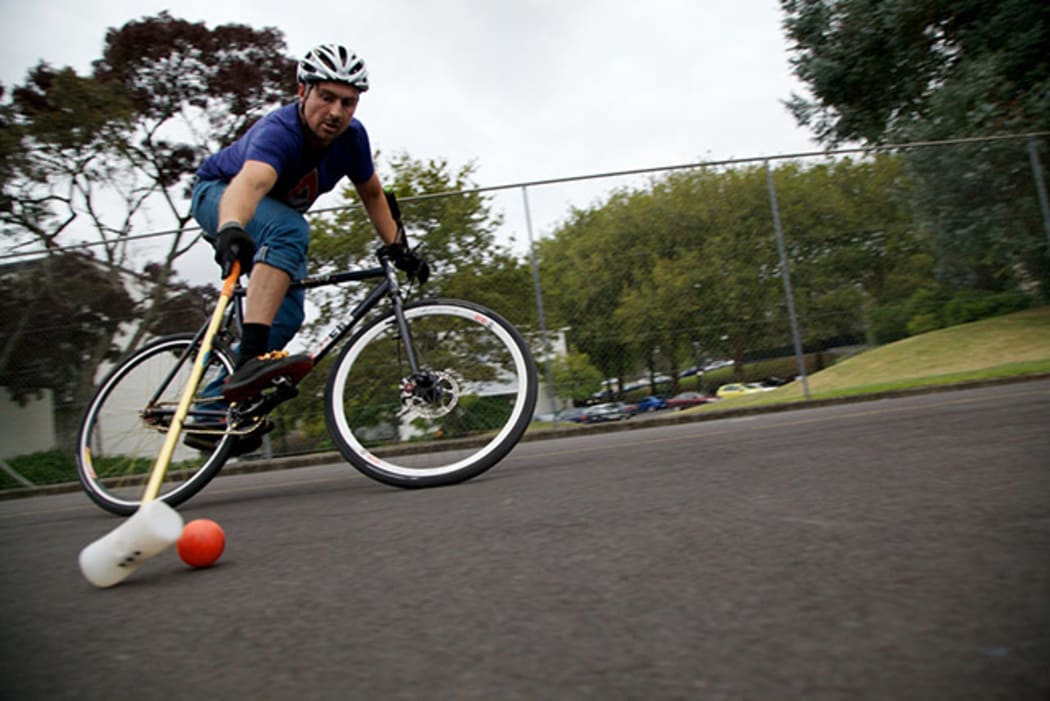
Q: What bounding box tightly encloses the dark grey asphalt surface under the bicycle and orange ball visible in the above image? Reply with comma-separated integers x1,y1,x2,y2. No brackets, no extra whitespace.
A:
0,381,1050,701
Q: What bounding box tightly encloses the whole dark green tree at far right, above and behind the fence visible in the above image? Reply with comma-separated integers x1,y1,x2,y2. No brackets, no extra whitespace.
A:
781,0,1050,296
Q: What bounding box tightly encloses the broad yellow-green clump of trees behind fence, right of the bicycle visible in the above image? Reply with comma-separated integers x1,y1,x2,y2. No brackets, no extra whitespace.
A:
539,155,932,390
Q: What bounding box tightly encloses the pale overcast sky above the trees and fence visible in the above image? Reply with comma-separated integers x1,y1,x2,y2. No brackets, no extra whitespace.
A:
0,0,818,274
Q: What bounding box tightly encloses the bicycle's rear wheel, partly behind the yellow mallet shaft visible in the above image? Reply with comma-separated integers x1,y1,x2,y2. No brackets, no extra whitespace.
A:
76,334,233,515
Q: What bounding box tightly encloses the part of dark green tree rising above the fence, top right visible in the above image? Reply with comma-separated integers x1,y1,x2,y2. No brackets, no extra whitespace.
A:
780,0,1050,144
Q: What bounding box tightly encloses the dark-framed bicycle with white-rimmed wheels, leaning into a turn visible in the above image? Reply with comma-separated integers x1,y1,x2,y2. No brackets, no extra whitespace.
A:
76,210,538,515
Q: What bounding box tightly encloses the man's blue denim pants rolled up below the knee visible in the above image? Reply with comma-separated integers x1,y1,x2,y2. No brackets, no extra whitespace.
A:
190,180,310,351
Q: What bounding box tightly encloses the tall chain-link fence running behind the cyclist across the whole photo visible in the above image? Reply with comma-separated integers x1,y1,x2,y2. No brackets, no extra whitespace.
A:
0,134,1050,487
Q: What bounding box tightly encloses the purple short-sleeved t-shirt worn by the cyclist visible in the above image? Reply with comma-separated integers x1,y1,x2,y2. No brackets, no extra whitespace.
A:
197,103,375,212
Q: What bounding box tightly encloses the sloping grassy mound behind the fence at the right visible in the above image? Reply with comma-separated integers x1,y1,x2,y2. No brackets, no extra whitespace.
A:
700,306,1050,410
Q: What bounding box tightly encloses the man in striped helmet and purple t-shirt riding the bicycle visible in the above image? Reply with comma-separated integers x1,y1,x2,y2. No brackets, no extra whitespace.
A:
187,44,429,453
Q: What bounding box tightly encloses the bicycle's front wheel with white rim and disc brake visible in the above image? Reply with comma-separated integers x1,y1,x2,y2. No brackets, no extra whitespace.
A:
324,299,537,487
